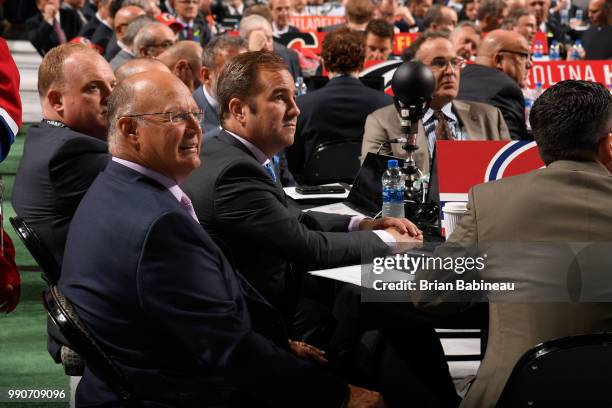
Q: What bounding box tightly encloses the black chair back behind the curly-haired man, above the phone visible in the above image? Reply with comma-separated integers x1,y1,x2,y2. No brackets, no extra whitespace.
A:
300,140,361,185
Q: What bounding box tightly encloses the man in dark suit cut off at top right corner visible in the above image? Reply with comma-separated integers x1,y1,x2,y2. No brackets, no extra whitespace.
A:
580,0,612,60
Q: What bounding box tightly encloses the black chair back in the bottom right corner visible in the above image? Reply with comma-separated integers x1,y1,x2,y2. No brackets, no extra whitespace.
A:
497,333,612,408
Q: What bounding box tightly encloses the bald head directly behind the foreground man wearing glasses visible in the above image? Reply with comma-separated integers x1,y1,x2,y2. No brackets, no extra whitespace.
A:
157,41,202,92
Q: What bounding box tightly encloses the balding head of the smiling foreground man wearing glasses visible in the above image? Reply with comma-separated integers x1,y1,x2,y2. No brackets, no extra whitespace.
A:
108,71,202,183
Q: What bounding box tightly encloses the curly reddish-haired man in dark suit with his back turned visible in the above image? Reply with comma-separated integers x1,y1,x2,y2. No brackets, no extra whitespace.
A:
287,29,393,178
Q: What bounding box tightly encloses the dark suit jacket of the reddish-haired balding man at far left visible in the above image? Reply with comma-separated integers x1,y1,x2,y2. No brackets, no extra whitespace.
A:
12,122,110,264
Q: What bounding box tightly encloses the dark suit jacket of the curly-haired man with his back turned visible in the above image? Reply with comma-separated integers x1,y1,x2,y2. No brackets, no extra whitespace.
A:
287,76,393,176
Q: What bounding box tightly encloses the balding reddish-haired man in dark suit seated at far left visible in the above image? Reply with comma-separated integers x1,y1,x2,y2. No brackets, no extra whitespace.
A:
12,44,115,362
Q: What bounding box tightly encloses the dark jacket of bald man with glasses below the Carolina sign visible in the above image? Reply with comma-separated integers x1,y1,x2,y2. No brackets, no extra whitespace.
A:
457,64,533,140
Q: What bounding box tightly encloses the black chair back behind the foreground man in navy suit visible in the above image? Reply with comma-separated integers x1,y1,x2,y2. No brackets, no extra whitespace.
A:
43,285,142,408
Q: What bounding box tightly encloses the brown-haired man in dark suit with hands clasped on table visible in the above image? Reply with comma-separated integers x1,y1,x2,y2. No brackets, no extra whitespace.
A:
184,51,419,332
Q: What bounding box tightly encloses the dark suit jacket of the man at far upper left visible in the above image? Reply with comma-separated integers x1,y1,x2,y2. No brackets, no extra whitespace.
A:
26,9,82,56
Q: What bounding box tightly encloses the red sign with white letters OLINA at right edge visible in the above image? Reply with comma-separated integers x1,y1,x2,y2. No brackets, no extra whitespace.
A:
529,60,612,89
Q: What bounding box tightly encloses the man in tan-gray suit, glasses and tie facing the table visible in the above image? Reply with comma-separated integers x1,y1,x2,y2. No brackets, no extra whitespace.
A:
361,32,510,173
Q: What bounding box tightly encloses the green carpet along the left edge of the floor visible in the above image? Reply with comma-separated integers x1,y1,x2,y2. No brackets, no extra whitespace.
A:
0,126,69,408
